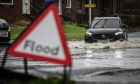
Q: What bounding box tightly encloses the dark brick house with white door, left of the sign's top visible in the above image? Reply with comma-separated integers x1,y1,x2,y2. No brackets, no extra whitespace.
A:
0,0,43,23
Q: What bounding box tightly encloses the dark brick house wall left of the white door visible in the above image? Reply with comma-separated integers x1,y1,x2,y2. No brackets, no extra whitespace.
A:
0,0,22,22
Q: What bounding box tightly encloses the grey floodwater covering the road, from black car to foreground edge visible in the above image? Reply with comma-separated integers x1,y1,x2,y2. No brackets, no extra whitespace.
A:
0,32,140,81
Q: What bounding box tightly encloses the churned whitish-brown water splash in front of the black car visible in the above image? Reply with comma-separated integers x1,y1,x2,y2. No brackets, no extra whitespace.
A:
68,41,140,49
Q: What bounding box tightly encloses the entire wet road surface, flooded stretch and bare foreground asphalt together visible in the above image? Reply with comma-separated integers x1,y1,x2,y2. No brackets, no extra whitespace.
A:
0,32,140,84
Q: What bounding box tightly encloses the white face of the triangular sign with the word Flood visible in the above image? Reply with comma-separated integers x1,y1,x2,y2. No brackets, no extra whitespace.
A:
16,11,64,60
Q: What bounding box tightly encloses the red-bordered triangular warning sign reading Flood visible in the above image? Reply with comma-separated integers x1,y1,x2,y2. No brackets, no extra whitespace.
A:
8,4,71,65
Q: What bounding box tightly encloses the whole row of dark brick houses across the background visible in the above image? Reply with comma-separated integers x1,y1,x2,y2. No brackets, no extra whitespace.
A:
0,0,139,24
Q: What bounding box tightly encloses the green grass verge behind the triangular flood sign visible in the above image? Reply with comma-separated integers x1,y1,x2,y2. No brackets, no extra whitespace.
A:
11,23,86,40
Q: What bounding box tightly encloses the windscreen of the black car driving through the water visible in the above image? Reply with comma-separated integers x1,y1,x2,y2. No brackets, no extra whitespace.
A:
91,19,120,28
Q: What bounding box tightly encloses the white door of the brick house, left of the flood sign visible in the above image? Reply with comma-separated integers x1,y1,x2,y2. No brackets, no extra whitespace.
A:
22,0,30,14
